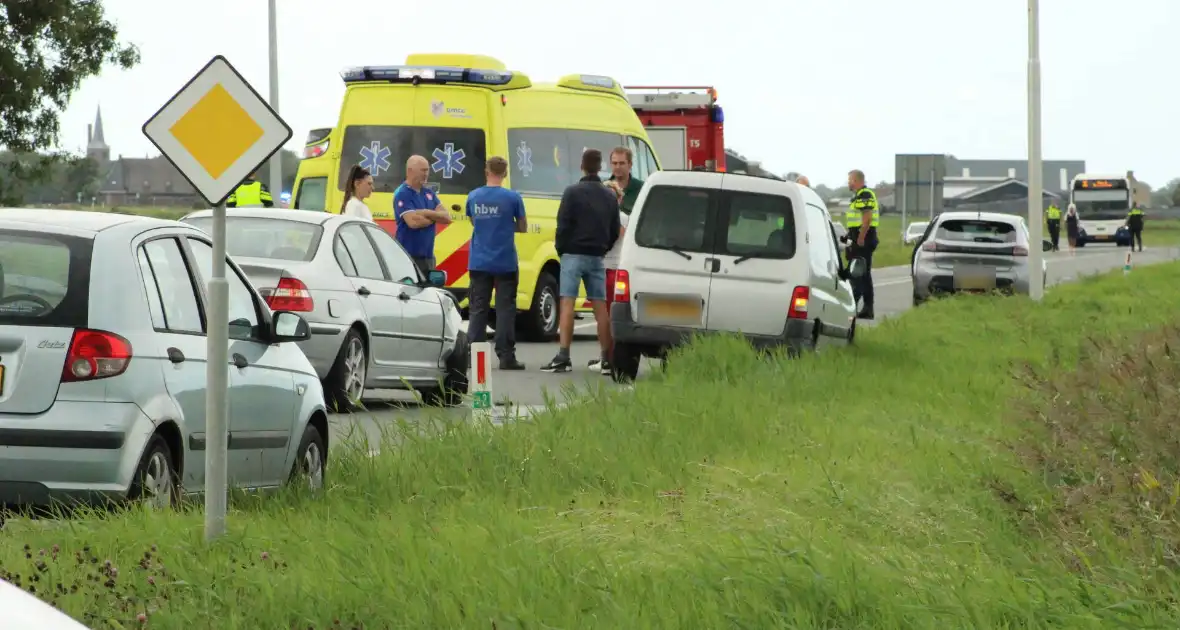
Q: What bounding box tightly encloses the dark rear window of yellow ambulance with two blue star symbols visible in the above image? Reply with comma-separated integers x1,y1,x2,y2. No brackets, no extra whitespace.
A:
336,125,487,195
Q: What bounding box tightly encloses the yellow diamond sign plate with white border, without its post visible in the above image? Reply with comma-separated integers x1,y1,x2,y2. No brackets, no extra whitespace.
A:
144,55,291,205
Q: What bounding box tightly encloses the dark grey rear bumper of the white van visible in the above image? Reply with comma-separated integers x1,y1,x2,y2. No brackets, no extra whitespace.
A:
610,302,815,355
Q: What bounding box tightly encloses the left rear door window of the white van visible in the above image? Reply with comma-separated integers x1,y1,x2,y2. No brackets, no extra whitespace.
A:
635,186,714,252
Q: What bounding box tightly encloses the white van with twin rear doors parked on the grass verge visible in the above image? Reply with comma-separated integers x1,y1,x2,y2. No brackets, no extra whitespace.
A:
610,171,864,381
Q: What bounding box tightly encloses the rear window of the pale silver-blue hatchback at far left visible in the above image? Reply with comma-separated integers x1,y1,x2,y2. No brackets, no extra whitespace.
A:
0,230,94,327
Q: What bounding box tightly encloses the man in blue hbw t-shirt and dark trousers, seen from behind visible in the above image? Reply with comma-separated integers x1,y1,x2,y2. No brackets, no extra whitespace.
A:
467,156,526,369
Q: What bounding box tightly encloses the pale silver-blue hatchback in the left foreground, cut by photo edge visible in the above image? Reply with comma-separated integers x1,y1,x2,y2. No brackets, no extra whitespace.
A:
0,209,328,506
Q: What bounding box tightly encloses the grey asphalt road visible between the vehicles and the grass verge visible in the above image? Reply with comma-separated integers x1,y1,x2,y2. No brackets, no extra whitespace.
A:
333,245,1180,440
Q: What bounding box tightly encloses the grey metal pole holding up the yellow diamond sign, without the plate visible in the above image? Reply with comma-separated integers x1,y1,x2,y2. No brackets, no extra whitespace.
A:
205,203,229,540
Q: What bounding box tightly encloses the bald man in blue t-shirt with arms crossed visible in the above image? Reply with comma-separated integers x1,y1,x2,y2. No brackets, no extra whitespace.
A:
393,156,451,276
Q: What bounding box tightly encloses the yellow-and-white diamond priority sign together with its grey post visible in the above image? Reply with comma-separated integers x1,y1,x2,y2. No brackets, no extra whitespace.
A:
143,55,291,540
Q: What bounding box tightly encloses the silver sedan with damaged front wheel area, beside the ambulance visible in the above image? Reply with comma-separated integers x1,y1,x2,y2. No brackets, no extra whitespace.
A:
182,208,470,411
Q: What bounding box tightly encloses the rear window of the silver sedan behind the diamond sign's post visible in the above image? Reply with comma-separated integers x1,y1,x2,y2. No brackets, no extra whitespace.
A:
184,216,323,261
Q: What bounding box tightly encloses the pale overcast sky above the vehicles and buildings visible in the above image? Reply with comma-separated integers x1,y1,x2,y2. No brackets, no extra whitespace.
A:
61,0,1180,186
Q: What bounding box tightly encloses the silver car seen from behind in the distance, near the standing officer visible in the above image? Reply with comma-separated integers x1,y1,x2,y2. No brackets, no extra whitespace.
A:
911,212,1053,306
